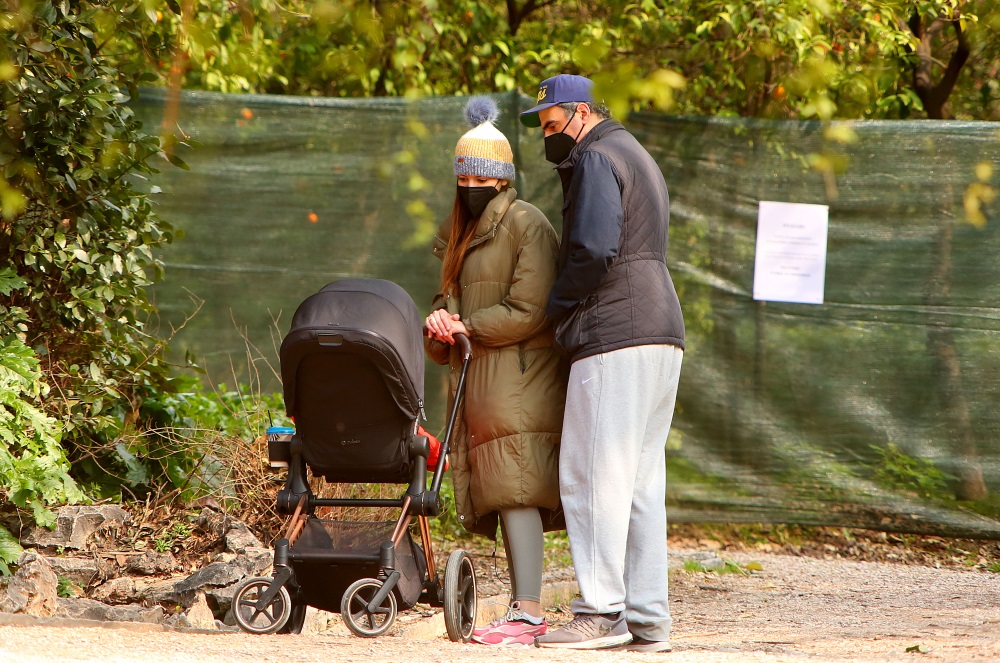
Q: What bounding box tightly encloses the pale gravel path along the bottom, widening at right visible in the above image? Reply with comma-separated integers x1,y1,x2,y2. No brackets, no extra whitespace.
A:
0,551,1000,663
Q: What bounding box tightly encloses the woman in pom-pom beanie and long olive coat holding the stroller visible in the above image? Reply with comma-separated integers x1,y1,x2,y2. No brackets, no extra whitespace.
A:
426,97,566,645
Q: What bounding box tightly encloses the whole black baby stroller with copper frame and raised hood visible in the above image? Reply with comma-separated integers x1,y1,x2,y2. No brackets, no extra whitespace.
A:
232,279,477,642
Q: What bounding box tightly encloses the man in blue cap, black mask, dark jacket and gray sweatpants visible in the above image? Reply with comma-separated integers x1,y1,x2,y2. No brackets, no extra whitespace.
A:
521,74,684,652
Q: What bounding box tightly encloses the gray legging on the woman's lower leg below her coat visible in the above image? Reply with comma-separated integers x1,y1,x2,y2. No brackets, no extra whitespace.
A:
500,507,545,602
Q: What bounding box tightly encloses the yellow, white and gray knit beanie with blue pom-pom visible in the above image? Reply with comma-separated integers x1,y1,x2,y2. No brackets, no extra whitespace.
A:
455,96,514,182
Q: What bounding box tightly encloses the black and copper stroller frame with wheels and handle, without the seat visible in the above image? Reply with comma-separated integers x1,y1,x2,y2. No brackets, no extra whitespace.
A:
232,278,477,642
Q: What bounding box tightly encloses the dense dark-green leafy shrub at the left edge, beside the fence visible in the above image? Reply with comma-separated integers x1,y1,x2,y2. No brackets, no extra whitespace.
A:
0,2,184,536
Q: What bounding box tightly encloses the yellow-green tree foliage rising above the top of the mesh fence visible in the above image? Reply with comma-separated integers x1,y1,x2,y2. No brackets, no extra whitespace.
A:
111,0,1000,119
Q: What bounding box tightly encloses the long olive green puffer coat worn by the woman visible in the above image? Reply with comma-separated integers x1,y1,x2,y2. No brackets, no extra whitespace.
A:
426,189,568,538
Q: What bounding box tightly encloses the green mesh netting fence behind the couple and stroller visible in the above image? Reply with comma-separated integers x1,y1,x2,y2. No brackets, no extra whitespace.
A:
136,91,1000,538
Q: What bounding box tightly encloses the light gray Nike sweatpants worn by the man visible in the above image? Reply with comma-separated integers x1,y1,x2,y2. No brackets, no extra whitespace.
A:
559,345,684,640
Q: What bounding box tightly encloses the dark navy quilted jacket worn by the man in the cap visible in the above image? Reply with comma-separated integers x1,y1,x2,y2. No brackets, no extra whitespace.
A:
546,120,684,361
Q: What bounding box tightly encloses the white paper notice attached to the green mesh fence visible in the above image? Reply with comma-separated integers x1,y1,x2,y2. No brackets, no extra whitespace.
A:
753,201,830,304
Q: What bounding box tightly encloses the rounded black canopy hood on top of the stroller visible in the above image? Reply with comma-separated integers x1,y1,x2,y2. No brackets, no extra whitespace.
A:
281,279,424,420
